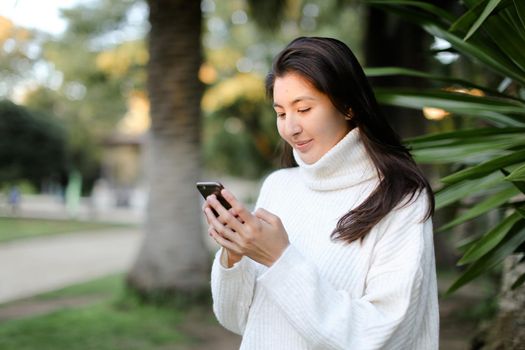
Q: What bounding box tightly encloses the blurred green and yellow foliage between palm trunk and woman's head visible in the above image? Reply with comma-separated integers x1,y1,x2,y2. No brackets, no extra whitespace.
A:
200,0,363,179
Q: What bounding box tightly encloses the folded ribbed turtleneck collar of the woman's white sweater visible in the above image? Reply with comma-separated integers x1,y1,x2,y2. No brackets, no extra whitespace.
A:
293,127,378,191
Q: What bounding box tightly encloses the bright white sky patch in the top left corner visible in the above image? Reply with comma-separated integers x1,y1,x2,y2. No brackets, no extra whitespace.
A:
0,0,86,34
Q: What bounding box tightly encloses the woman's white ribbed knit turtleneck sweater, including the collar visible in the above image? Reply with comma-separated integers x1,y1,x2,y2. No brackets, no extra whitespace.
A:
211,128,439,350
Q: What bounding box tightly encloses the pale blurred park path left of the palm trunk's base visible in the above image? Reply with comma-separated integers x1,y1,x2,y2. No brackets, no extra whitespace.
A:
0,228,141,304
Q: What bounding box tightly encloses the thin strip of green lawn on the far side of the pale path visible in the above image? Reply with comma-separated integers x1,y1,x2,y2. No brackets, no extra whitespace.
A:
0,217,133,242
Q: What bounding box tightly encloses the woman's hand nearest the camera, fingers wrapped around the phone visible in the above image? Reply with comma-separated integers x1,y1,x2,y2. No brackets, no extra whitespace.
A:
205,190,290,266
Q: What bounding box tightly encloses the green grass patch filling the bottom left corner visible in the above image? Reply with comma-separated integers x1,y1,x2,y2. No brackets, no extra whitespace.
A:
0,302,185,350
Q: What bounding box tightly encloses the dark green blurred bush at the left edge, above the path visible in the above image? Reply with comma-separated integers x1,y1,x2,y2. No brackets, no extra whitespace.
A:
0,100,68,188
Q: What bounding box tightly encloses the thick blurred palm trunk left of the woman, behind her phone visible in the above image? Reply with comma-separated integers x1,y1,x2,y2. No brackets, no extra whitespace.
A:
128,0,208,295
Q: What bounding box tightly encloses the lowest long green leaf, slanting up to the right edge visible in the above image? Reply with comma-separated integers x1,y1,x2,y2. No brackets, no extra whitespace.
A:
446,223,525,295
